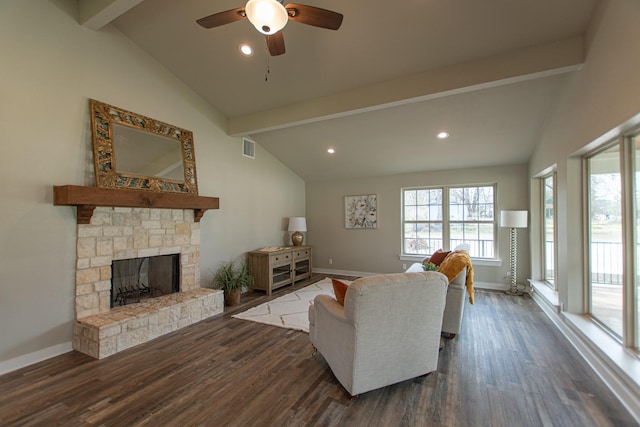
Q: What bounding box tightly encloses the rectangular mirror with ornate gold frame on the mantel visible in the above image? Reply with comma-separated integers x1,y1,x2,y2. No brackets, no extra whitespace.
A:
90,99,198,196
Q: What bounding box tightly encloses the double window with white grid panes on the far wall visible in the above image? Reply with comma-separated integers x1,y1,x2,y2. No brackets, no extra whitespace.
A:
402,185,496,258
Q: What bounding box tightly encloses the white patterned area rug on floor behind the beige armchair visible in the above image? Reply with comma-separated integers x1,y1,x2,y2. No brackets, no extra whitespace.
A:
232,278,350,333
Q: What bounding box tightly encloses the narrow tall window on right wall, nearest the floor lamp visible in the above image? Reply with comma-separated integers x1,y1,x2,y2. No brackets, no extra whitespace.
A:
541,173,556,289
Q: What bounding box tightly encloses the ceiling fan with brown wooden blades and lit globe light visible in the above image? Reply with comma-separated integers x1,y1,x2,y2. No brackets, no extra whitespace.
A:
196,0,343,56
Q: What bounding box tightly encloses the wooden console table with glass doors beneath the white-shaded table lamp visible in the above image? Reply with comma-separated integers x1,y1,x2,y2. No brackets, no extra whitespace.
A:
249,246,312,295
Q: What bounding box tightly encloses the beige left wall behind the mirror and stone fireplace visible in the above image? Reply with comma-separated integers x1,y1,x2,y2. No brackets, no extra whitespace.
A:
0,0,305,371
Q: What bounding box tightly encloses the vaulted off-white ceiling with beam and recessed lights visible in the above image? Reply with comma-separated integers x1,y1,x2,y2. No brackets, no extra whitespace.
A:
79,0,597,181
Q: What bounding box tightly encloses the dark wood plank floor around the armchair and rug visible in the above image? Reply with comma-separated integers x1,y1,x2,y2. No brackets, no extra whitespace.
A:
0,277,636,427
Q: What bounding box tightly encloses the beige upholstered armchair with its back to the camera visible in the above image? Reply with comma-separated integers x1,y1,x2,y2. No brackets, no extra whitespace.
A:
309,272,448,396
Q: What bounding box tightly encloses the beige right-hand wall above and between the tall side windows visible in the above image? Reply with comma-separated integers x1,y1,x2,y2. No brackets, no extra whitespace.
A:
529,0,640,313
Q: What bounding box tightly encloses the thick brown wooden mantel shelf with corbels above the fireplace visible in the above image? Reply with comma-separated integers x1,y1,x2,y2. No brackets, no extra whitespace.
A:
53,185,220,224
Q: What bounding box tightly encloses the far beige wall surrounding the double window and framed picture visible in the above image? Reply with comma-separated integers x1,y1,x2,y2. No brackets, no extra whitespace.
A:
307,166,529,284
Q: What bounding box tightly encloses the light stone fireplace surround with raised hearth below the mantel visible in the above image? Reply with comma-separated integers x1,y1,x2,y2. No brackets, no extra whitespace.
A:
73,207,223,358
